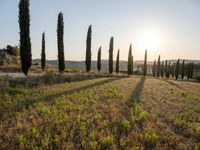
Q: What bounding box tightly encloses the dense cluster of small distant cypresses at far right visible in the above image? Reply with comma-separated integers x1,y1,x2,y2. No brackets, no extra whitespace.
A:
152,55,194,80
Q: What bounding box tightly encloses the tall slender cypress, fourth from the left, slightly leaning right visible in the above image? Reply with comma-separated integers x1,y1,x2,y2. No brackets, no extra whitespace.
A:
85,25,92,72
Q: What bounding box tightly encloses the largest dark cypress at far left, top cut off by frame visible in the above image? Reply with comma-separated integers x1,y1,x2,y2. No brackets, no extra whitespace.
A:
19,0,32,75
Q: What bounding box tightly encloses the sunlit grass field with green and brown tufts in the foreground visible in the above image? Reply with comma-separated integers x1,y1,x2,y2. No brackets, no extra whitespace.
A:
0,76,200,150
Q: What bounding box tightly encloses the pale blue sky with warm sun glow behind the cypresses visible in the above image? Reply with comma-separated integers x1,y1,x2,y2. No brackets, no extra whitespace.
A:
0,0,200,60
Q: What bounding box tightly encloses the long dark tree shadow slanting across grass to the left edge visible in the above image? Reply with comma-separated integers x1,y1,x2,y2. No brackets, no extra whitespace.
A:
0,77,125,119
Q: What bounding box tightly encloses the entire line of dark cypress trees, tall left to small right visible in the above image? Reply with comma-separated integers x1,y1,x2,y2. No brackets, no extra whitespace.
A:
19,0,198,80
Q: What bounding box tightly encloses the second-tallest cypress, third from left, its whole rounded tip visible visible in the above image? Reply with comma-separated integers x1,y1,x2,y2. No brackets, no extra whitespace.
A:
57,12,65,72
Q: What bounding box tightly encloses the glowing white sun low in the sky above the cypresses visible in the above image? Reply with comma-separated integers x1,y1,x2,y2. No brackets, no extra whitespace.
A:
138,32,161,51
